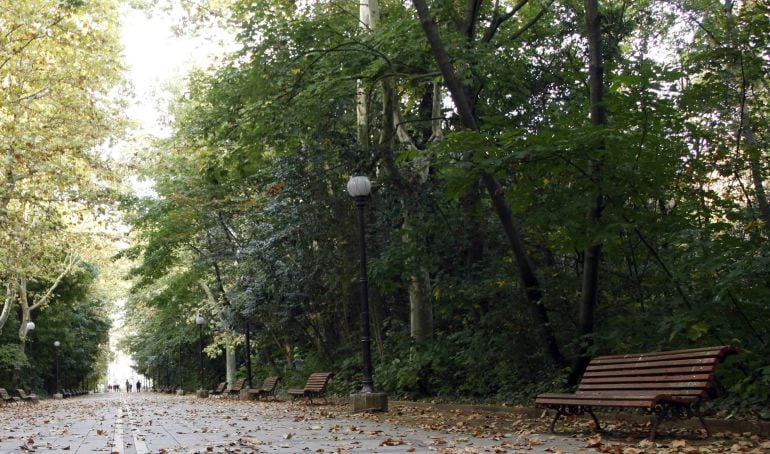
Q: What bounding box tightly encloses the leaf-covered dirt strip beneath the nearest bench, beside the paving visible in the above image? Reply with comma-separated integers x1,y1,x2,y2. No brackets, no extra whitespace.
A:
338,402,770,454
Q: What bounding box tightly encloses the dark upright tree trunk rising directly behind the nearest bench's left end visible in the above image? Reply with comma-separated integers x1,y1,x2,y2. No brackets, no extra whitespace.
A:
568,0,607,385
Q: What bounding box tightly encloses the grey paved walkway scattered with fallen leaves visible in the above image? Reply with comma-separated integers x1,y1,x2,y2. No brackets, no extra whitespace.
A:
0,393,585,454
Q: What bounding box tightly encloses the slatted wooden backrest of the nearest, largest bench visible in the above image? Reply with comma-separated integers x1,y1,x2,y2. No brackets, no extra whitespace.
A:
577,345,737,397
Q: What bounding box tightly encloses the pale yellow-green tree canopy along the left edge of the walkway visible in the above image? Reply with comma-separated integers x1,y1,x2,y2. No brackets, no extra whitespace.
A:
0,0,122,390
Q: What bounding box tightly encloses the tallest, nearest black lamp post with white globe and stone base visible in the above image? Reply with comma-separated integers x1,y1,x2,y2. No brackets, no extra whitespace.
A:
348,176,387,412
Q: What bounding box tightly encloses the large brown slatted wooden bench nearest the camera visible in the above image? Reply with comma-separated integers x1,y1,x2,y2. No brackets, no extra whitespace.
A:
535,345,737,440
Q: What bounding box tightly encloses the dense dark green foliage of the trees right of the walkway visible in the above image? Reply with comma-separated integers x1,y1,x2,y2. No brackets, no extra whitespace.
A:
117,1,770,414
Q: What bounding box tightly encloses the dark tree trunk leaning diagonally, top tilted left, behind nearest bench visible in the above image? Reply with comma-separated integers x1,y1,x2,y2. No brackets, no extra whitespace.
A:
412,0,564,365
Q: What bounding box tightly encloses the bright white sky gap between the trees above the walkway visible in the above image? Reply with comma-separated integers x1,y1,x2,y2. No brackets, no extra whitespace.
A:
107,4,232,384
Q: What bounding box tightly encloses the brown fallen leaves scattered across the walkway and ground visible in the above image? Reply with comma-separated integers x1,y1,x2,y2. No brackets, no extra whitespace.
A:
0,397,770,454
